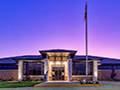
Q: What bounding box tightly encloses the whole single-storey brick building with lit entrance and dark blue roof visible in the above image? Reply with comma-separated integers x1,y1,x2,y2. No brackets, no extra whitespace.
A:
0,49,120,81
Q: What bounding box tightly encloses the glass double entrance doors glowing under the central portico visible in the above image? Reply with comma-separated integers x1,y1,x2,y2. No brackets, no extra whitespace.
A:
52,67,64,80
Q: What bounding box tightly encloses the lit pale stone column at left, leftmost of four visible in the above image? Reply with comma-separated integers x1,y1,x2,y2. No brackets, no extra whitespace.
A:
18,60,23,81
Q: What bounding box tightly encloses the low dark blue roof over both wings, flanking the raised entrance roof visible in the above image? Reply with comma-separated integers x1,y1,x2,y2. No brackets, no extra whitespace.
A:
0,55,120,65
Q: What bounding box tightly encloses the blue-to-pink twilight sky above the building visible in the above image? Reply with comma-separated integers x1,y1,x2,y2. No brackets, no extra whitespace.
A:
0,0,120,59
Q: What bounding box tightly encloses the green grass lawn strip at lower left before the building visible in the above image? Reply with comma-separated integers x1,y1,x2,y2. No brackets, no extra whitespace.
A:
0,81,41,88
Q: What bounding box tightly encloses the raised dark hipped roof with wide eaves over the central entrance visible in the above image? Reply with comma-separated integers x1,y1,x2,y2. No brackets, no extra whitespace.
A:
39,49,77,57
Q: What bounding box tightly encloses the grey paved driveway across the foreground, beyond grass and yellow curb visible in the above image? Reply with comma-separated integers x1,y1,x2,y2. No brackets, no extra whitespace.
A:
0,82,120,90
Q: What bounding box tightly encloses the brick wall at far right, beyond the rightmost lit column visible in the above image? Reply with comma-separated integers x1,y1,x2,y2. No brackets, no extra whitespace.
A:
98,70,120,81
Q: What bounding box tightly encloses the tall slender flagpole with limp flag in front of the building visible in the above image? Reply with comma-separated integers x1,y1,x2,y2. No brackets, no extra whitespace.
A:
85,2,88,82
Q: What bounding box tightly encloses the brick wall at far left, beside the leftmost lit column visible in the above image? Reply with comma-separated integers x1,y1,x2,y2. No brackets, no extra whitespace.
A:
0,70,18,80
